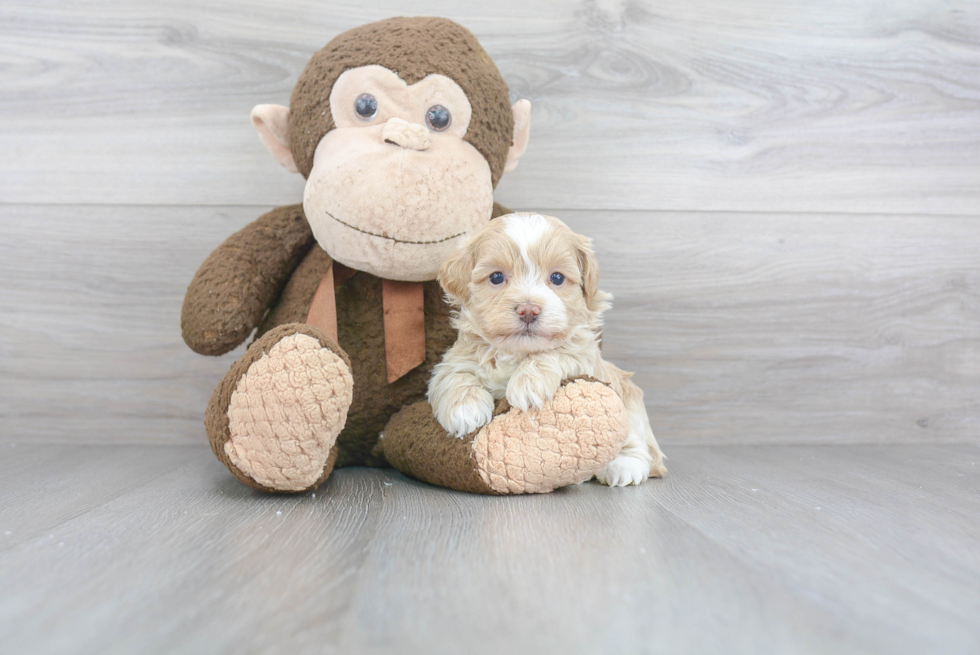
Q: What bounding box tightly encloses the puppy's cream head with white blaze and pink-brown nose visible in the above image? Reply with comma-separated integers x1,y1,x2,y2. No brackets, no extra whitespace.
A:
439,213,609,352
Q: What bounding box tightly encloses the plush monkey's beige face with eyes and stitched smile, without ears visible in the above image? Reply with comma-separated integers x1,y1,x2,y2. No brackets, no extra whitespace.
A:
303,65,493,281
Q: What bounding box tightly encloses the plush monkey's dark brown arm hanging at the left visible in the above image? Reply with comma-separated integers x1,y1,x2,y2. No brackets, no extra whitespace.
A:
180,205,314,355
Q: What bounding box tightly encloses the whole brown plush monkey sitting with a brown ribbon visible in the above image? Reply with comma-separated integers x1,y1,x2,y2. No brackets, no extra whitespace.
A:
181,18,626,493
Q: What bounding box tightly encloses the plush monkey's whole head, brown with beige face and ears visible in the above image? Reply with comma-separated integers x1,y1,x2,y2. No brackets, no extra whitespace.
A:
252,17,531,281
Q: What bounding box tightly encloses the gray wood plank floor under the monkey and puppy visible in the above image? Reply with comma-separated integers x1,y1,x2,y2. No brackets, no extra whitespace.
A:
0,444,980,654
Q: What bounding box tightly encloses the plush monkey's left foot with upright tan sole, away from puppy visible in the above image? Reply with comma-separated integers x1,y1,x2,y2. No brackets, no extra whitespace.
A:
205,323,354,493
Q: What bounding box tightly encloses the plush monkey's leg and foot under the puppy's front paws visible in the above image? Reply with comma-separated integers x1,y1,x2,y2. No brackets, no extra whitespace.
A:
379,378,629,494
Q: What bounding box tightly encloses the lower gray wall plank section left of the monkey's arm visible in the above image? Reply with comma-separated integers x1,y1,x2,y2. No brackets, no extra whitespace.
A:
0,205,249,444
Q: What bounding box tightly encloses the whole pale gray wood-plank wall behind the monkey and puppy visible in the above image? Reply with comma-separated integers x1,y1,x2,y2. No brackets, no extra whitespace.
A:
0,0,980,444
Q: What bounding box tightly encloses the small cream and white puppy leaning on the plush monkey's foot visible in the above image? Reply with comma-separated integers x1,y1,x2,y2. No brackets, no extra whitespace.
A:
429,213,667,487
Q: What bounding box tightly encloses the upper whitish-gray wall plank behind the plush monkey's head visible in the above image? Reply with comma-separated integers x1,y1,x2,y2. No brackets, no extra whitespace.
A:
0,0,980,215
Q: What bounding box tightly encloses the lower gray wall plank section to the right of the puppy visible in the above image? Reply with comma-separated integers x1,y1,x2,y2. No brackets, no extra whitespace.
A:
562,212,980,443
